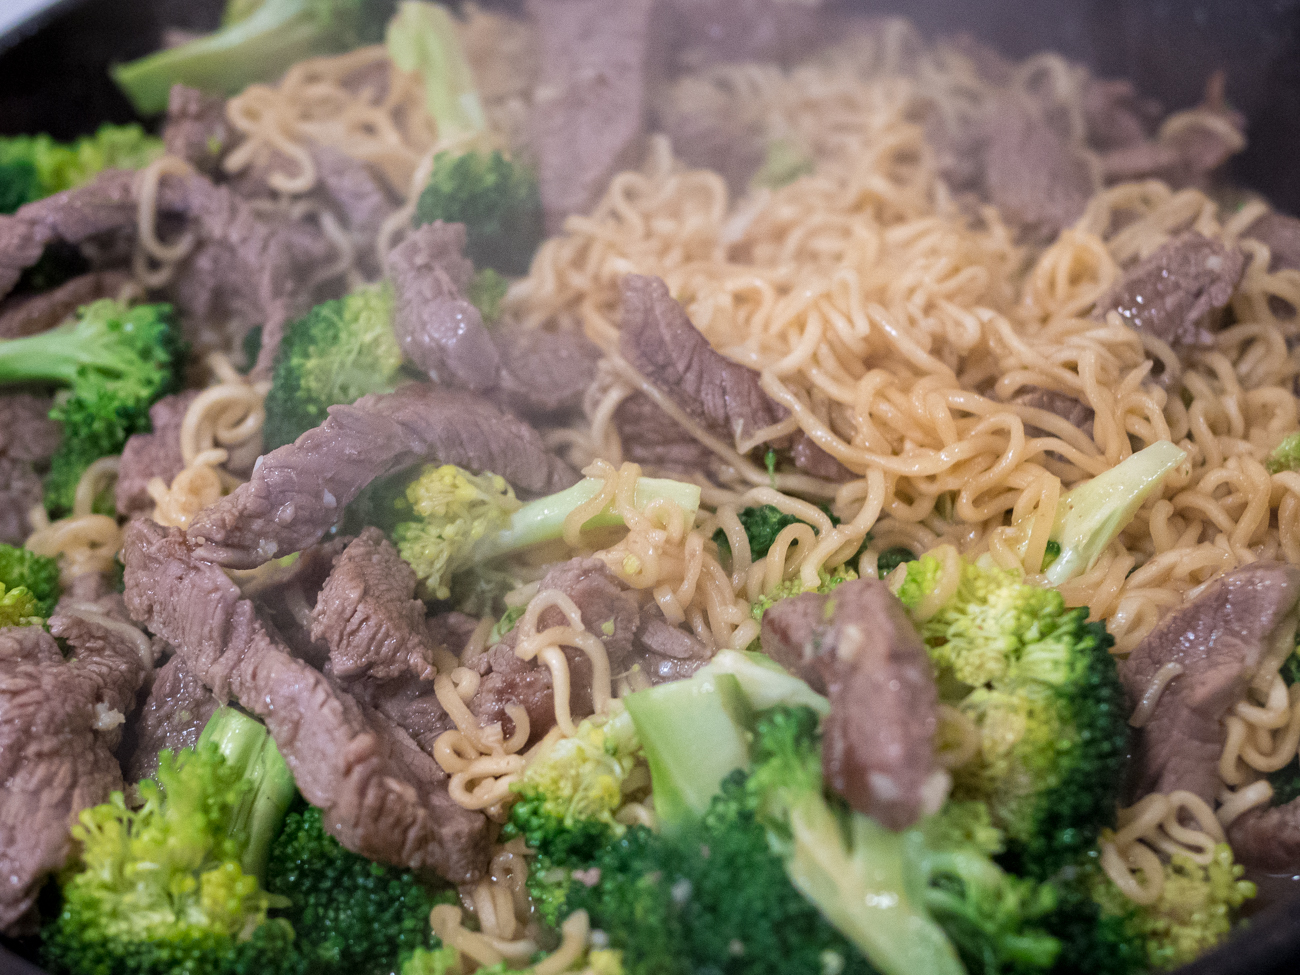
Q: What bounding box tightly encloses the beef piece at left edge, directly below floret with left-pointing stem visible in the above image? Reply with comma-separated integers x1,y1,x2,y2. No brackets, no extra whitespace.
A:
0,393,62,546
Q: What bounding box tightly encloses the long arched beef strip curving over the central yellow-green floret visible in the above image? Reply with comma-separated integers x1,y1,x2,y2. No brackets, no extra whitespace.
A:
190,382,579,568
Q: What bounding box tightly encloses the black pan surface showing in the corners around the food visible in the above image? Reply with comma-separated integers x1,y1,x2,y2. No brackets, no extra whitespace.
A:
0,0,1300,975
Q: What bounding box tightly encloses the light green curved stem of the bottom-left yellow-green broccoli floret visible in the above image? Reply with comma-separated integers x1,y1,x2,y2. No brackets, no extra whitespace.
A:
198,707,298,883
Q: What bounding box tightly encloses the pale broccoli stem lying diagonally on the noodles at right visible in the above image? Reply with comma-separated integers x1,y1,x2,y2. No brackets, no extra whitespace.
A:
1047,441,1187,585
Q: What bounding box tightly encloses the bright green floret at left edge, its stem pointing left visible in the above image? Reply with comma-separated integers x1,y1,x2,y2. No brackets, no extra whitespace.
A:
0,298,185,515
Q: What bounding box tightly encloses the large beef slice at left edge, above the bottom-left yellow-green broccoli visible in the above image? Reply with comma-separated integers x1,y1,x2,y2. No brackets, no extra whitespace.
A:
0,615,147,935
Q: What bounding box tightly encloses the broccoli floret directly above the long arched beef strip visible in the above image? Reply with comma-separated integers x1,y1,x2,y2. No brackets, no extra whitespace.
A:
263,285,402,450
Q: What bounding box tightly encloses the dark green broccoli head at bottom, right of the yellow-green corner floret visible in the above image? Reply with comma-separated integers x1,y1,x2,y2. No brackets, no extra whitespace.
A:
267,807,455,975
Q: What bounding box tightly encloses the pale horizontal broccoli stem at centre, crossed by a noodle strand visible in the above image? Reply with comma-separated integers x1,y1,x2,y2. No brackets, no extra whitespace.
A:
473,477,699,563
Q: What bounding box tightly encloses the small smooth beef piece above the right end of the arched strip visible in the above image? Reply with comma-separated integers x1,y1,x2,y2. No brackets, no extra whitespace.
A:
493,324,601,421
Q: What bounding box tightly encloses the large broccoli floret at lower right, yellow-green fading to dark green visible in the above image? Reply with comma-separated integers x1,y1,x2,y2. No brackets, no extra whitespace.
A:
898,555,1128,878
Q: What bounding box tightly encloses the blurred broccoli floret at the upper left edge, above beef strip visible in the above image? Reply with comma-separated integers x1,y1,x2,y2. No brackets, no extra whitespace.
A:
0,124,163,213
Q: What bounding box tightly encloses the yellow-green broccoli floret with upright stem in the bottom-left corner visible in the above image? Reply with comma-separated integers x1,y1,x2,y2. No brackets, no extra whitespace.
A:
42,707,303,975
